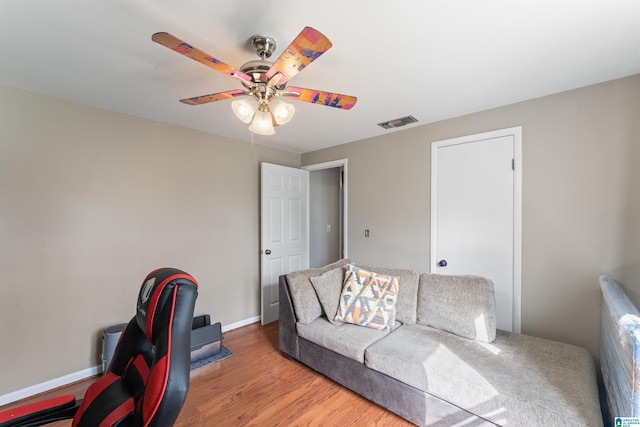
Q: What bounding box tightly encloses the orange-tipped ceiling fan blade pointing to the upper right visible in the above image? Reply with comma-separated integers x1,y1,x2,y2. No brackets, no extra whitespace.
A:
266,27,332,85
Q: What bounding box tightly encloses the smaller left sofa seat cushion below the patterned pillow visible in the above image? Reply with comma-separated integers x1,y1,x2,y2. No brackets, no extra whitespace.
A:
296,317,389,363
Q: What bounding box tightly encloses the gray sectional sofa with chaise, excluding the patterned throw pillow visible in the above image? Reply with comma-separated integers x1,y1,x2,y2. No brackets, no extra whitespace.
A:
279,260,603,426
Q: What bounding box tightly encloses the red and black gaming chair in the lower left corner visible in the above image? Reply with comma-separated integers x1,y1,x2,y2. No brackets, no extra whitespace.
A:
0,268,198,427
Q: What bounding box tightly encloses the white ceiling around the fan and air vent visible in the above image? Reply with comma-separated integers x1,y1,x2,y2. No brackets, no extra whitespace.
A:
0,0,640,153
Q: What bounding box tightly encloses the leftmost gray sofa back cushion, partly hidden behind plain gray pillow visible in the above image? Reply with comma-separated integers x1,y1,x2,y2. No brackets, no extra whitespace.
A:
286,259,349,324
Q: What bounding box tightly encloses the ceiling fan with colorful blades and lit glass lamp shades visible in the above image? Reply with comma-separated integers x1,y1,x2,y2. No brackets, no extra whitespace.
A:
151,27,357,135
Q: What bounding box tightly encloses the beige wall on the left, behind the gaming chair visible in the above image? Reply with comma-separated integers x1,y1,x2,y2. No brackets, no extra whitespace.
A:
0,87,300,395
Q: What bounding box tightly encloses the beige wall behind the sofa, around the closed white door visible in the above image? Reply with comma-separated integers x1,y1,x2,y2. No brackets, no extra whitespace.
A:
302,75,640,355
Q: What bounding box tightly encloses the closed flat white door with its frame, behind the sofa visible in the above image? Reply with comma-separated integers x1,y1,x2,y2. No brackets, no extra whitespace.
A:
431,128,521,332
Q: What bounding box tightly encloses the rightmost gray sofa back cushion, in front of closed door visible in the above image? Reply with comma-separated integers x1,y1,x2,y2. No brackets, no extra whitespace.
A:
417,274,496,342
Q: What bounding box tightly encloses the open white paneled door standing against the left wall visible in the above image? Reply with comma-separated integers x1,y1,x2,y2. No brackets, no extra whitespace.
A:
260,163,309,325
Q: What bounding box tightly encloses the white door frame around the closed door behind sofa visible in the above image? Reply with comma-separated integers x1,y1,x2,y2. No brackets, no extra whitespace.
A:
429,126,522,333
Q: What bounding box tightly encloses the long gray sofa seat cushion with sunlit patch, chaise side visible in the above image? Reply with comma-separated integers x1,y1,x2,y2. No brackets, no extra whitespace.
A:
365,324,602,426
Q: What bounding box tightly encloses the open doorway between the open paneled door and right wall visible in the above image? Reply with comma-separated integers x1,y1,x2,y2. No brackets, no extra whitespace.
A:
302,159,347,268
